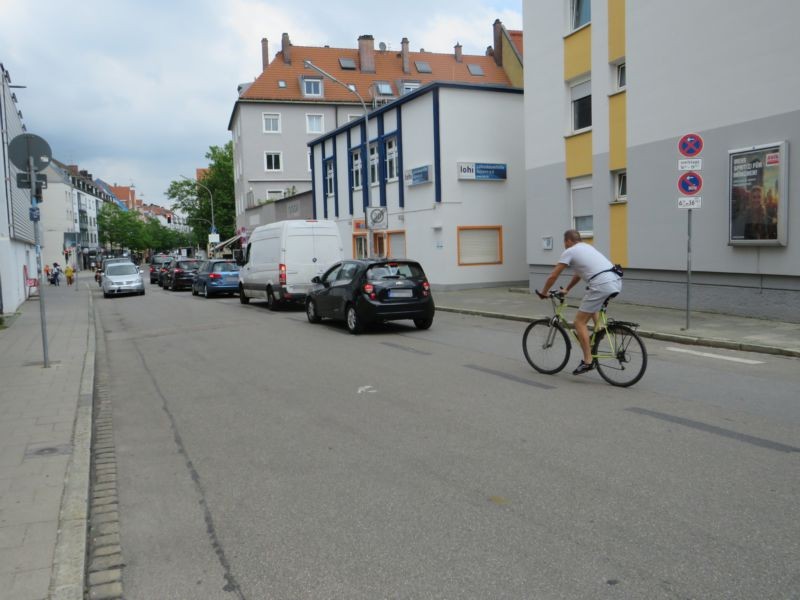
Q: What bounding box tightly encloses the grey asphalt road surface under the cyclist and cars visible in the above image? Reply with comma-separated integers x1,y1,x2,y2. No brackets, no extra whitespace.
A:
95,286,800,600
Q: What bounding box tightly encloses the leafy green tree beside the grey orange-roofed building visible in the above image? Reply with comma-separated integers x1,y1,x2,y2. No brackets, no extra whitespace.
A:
166,142,236,247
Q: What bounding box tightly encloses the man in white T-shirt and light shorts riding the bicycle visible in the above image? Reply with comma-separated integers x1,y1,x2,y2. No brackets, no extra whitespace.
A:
536,229,622,375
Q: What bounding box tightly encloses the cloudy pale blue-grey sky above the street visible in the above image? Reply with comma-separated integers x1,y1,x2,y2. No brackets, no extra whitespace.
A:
0,0,522,206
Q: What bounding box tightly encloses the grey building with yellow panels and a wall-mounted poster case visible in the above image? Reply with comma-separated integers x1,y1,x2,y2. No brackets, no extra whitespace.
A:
523,0,800,321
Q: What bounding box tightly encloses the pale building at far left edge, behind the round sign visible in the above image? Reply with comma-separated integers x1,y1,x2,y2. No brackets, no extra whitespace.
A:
0,63,37,315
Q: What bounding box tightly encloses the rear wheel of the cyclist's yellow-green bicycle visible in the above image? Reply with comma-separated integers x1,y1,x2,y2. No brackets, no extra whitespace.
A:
592,323,647,387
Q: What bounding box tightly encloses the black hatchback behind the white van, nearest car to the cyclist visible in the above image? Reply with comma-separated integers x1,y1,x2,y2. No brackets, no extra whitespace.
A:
306,259,435,334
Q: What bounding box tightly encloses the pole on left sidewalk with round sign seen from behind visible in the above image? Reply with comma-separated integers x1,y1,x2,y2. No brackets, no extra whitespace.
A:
8,133,52,369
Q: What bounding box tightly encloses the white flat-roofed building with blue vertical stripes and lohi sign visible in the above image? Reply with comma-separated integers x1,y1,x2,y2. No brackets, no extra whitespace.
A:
310,83,527,289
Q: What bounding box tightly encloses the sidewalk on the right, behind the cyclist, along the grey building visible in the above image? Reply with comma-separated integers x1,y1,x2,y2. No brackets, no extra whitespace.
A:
433,287,800,357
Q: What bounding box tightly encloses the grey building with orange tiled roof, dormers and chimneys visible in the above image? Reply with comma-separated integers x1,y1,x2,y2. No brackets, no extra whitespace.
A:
228,21,521,234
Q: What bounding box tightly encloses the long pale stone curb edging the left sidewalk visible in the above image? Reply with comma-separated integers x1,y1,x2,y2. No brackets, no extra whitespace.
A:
50,288,96,600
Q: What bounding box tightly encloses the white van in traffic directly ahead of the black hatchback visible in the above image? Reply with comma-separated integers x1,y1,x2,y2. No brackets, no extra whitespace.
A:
237,220,343,310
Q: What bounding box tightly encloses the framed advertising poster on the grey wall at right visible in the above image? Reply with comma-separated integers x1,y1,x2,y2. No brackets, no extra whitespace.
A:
729,143,787,245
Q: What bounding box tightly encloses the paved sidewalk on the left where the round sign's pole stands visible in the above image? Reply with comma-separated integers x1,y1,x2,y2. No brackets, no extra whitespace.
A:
0,271,95,600
